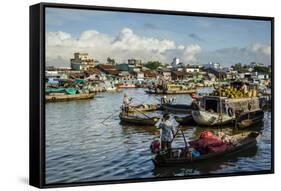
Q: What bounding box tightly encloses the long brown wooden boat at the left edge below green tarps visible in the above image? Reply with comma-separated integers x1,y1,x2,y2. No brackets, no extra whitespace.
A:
45,93,95,102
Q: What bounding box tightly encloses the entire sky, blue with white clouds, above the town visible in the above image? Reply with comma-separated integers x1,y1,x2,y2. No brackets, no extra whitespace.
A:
46,8,271,66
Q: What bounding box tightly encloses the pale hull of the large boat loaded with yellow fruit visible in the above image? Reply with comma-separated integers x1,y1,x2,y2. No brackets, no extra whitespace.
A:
192,110,235,126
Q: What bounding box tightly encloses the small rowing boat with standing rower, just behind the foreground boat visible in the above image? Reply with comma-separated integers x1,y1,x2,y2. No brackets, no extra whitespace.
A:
119,113,160,126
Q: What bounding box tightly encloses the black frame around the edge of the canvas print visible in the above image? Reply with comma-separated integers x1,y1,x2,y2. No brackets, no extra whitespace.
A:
29,3,274,188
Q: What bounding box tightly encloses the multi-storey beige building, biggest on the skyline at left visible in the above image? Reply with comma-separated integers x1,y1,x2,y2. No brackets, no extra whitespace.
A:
70,52,96,70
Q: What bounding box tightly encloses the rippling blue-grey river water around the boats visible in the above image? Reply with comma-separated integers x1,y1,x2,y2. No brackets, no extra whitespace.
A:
46,89,271,184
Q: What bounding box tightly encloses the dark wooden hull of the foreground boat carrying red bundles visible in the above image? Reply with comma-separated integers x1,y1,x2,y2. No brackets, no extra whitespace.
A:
152,132,260,166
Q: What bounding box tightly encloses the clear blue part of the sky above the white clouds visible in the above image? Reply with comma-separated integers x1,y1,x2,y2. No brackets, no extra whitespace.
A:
46,8,271,67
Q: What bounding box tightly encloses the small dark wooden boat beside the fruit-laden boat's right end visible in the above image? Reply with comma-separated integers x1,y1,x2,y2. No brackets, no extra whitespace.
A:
237,110,264,129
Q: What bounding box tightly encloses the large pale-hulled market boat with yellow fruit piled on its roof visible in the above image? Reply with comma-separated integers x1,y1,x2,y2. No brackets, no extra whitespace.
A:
192,84,261,126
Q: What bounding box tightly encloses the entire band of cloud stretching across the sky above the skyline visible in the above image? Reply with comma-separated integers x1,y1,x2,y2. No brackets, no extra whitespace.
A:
46,28,271,66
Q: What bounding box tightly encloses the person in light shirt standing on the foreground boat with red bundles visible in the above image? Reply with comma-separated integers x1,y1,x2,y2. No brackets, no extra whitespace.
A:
158,113,175,150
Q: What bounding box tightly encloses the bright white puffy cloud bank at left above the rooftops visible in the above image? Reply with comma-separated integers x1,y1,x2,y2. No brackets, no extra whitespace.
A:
46,28,201,66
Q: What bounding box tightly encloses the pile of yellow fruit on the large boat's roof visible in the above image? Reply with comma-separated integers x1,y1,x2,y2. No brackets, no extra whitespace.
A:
210,87,249,98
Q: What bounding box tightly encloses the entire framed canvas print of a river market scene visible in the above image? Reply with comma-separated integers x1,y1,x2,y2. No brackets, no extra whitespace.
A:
30,3,274,188
